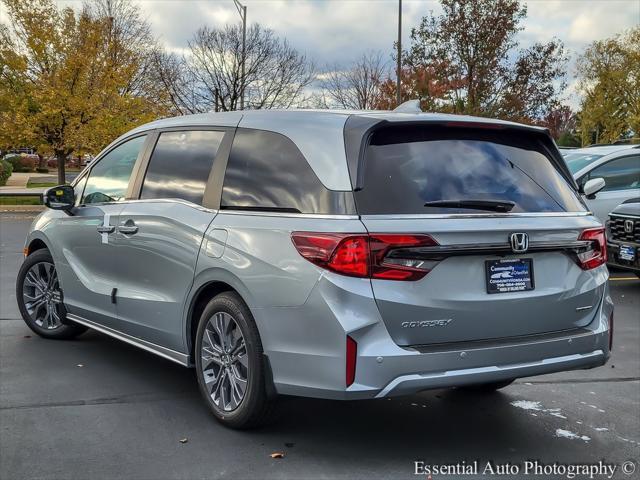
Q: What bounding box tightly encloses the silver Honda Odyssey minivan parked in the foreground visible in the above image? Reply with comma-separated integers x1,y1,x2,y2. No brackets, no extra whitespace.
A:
17,110,613,428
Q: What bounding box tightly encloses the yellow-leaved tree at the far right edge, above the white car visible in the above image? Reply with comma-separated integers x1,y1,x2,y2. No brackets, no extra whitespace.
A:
577,27,640,144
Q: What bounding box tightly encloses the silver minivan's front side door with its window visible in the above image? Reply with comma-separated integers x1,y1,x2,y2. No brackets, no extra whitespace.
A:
54,135,146,330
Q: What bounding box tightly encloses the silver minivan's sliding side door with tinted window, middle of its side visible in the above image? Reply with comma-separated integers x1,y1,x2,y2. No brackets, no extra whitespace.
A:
116,129,231,351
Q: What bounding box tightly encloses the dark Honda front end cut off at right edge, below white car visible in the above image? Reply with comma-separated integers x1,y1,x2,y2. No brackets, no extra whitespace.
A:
607,197,640,277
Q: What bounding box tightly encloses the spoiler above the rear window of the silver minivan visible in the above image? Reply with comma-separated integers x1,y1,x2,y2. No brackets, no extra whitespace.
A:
344,115,580,192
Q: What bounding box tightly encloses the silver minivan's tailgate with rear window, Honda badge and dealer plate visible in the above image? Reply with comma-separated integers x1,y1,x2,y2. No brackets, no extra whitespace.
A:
355,126,606,345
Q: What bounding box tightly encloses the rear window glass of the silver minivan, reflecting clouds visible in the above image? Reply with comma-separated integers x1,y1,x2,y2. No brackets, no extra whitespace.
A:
356,126,584,214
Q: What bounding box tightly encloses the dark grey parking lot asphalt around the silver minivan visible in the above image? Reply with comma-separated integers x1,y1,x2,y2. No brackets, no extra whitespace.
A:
0,213,640,480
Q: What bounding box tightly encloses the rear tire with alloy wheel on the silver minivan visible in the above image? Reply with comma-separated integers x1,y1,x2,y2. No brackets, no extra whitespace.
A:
194,292,276,429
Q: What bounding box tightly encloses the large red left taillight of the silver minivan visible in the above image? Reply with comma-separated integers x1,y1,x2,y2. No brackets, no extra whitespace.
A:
291,232,438,281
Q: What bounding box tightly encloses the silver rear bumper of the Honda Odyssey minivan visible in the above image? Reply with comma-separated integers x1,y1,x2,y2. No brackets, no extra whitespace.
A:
261,272,613,400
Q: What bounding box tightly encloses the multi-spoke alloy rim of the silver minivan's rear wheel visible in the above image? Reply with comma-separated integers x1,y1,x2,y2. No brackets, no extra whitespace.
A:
200,312,249,412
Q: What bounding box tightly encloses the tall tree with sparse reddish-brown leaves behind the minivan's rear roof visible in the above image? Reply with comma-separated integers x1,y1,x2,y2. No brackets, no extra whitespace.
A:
404,0,567,121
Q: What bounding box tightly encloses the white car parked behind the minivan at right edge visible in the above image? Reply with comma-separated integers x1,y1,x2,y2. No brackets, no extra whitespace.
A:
564,145,640,223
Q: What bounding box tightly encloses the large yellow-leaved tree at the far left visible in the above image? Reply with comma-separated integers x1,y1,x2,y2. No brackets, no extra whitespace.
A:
0,0,161,183
